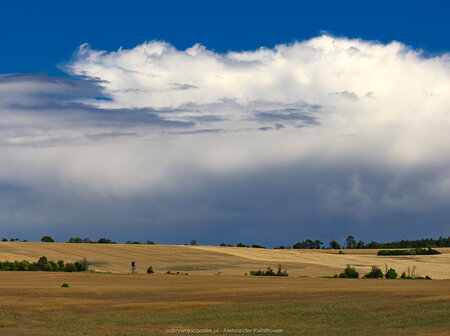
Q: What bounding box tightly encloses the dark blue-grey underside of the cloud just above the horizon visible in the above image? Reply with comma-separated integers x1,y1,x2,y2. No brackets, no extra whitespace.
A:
0,161,450,246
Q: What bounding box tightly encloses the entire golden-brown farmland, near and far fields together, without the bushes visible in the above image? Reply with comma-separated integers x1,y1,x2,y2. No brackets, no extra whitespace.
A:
0,243,450,336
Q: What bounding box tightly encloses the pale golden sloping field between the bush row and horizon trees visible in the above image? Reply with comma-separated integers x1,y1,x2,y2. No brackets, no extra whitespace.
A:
0,242,450,279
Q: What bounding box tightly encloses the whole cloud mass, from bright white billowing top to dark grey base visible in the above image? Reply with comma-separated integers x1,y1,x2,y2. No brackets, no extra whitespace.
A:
0,35,450,244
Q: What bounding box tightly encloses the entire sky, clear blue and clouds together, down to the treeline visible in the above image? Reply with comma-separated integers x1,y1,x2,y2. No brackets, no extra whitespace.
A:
0,1,450,246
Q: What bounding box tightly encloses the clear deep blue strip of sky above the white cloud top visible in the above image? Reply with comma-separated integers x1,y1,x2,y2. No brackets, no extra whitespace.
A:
0,0,450,74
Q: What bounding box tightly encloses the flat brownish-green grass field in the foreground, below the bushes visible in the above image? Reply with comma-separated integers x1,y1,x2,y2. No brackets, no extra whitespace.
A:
0,272,450,336
